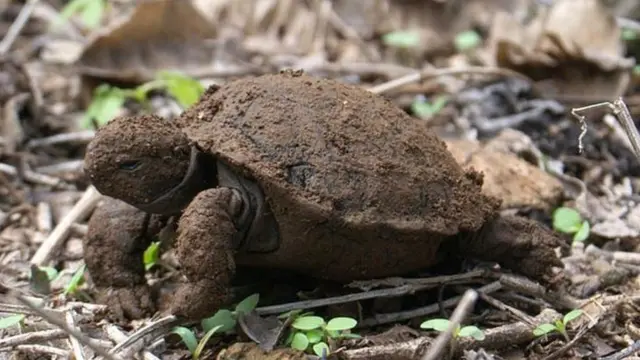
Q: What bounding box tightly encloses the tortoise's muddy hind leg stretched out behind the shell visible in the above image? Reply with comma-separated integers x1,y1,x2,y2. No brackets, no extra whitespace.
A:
459,215,564,282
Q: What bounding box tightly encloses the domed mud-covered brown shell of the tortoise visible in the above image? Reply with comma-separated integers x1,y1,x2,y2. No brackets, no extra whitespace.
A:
178,72,499,235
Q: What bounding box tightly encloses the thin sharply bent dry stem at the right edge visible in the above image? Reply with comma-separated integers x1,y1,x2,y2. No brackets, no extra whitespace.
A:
571,97,640,160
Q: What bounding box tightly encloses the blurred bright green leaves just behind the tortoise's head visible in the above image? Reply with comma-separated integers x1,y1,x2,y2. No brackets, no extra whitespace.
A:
81,71,205,129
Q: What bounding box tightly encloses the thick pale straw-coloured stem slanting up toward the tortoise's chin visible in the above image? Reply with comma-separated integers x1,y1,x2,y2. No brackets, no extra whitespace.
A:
31,186,102,266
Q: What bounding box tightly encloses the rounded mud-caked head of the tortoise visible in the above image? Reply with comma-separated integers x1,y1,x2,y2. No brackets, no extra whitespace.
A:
84,115,195,213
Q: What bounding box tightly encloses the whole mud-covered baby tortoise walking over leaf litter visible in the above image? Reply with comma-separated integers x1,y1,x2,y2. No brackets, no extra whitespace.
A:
85,71,562,319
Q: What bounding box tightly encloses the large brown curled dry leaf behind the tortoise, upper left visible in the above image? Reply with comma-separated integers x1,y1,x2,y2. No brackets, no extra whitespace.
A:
76,0,217,83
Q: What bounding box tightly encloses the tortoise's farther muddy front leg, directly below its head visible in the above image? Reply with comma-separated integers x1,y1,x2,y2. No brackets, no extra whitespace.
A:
83,197,166,319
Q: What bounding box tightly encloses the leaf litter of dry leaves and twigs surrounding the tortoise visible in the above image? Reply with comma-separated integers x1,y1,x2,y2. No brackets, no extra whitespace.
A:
0,0,640,359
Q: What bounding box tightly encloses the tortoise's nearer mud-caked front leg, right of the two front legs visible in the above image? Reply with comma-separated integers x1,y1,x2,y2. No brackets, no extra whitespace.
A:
170,188,242,320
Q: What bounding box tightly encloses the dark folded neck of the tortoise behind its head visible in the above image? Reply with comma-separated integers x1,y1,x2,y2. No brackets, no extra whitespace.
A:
132,146,208,215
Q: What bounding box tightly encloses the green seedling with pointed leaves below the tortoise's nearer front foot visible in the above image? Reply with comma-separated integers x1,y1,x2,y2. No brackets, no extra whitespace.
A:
171,294,260,360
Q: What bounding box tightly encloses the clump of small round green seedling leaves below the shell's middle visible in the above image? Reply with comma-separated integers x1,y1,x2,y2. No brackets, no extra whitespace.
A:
280,312,360,357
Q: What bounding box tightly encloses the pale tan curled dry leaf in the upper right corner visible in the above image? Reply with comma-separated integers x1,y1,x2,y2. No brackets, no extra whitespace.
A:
485,0,634,99
